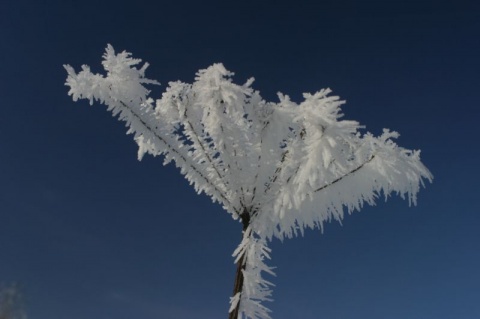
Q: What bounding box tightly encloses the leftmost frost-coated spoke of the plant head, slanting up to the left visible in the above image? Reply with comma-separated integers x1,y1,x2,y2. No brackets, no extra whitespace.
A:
65,47,239,216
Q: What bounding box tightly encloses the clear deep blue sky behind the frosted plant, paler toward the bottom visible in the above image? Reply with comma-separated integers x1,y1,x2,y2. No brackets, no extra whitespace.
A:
0,0,480,319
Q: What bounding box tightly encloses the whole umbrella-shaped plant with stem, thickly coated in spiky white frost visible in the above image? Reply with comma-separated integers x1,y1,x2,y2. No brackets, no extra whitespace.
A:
65,45,432,319
